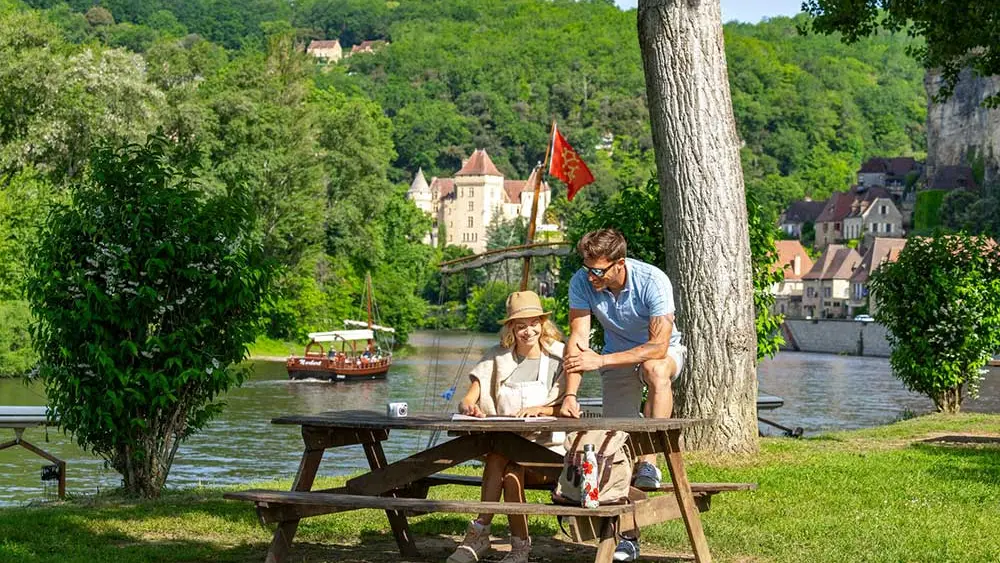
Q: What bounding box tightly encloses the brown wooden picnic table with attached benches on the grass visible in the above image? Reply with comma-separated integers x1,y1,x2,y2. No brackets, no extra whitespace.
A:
225,411,753,563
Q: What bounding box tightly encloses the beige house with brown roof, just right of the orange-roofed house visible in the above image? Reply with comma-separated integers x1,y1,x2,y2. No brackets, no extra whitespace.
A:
802,244,861,319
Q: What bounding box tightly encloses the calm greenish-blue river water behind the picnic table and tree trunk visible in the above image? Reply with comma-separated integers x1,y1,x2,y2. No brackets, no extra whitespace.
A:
0,332,1000,506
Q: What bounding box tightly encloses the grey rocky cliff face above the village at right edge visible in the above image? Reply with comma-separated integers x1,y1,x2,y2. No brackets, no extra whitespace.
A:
924,70,1000,184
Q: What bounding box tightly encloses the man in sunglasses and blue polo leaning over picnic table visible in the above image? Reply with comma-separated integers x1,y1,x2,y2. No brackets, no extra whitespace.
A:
560,229,687,561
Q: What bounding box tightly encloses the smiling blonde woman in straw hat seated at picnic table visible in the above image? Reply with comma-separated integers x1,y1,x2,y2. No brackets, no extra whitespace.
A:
448,291,564,563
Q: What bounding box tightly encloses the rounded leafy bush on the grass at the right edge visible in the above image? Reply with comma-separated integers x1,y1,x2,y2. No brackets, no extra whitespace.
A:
870,235,1000,413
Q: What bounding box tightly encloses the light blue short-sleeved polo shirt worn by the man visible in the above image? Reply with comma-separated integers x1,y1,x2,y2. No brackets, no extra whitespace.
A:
569,258,681,354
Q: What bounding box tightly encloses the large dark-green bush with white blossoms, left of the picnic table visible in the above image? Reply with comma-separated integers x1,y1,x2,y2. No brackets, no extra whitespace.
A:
27,137,271,498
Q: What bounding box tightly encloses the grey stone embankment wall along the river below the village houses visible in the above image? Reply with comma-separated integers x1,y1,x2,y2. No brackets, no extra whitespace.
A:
782,319,890,358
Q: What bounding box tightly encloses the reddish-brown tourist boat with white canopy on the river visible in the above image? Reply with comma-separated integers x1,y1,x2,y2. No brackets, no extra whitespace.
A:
285,275,396,381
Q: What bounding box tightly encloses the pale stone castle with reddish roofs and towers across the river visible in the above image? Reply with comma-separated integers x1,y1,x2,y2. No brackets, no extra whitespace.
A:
406,149,556,253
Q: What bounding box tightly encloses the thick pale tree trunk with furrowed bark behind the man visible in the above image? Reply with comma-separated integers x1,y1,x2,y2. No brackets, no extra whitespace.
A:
638,0,758,452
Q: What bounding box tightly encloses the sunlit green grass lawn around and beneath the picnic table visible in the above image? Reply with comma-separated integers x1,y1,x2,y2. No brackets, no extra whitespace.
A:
0,414,1000,563
